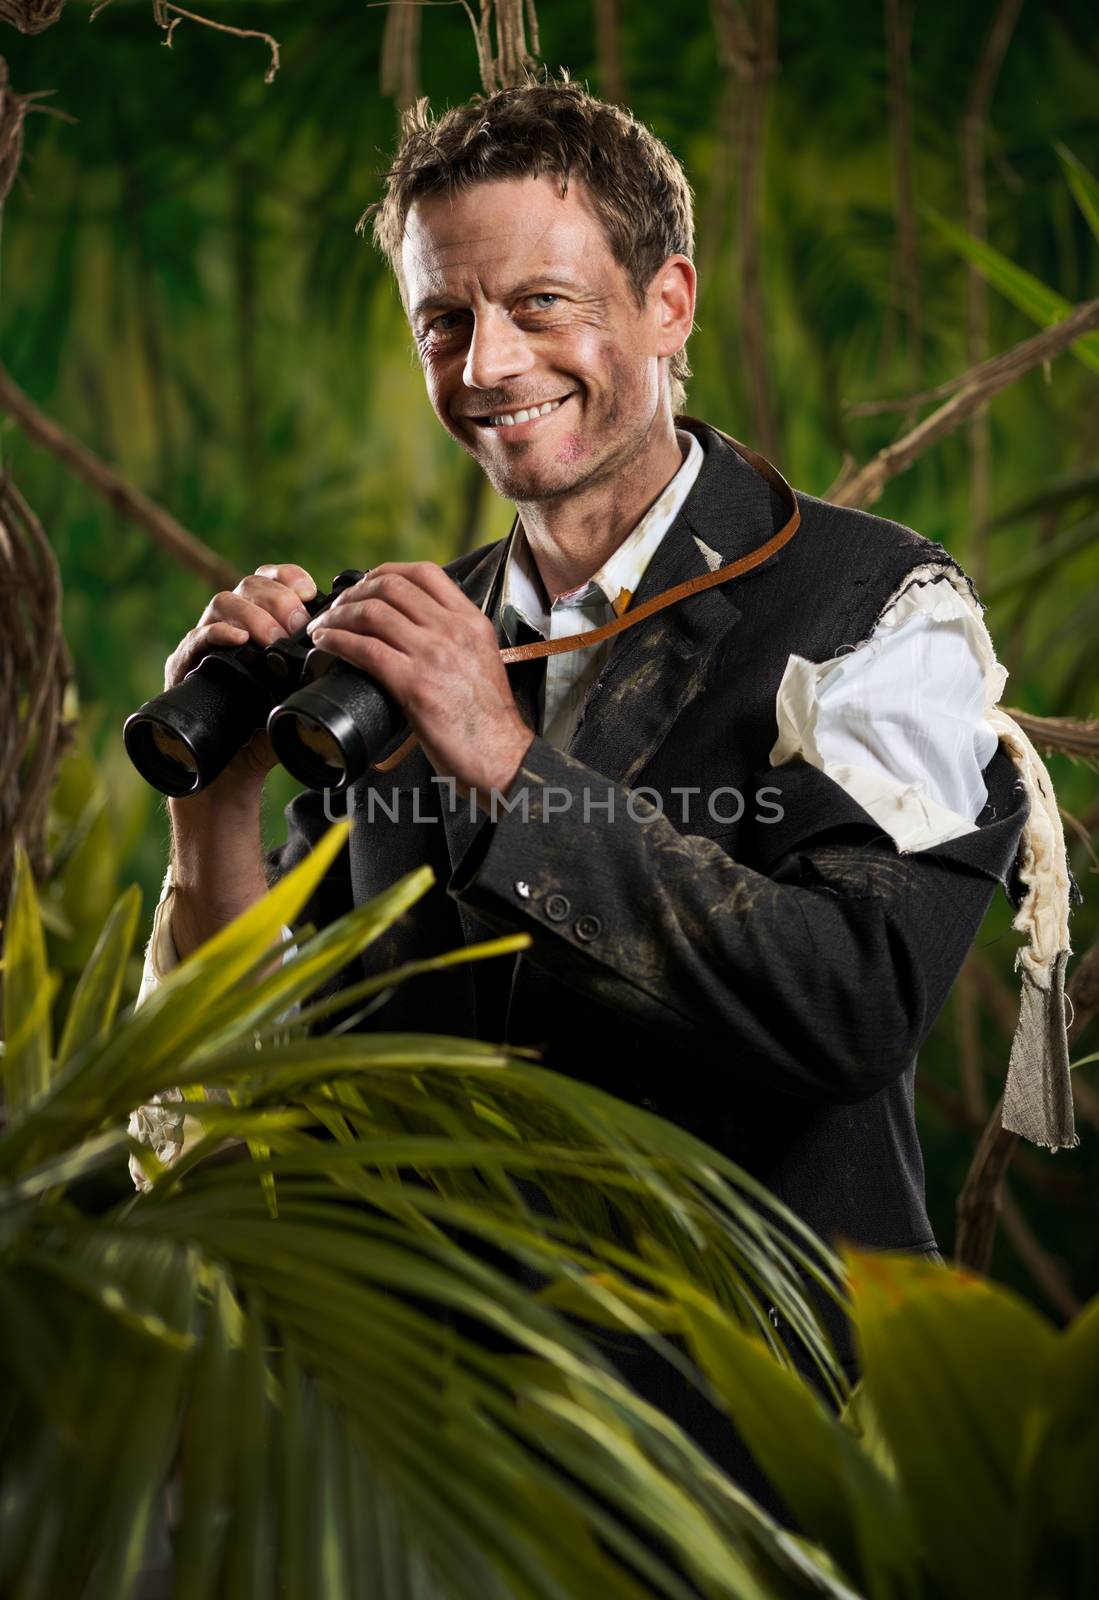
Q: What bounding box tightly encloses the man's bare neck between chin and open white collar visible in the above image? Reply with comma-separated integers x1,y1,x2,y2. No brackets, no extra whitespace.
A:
517,427,683,605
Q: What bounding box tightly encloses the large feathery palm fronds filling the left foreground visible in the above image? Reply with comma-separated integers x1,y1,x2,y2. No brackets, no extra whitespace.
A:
0,827,845,1600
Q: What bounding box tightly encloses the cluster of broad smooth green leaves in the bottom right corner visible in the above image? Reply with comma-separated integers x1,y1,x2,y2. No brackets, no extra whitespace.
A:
683,1251,1099,1600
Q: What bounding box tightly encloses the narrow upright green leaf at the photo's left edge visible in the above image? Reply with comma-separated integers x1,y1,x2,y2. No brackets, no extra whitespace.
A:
0,845,53,1125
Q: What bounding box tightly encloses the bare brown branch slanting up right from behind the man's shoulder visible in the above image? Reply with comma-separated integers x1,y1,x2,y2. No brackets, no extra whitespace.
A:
830,299,1099,506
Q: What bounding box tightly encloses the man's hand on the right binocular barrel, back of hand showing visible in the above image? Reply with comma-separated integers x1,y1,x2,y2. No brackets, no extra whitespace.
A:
310,562,531,810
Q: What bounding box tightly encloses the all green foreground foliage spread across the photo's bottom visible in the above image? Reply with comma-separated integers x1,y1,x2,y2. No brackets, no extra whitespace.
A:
0,827,1099,1600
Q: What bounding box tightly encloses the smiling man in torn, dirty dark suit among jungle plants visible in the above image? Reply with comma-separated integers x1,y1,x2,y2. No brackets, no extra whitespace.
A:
135,82,1067,1472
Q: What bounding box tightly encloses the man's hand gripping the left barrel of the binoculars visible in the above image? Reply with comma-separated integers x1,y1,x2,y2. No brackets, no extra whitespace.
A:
165,562,317,810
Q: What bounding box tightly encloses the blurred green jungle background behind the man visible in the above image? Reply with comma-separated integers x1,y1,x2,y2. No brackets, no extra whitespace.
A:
0,0,1099,1318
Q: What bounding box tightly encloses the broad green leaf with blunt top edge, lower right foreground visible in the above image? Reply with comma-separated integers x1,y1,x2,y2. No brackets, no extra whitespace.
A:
846,1253,1056,1600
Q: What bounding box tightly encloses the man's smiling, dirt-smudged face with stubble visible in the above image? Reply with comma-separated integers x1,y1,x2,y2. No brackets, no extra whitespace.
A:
402,178,693,501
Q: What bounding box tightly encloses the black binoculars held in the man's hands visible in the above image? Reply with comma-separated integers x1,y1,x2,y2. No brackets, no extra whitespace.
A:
123,570,405,795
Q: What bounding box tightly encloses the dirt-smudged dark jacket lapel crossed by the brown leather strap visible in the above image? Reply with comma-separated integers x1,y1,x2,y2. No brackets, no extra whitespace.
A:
569,419,789,786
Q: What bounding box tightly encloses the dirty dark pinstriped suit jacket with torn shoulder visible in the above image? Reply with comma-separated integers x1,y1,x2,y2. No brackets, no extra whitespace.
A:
275,424,1027,1286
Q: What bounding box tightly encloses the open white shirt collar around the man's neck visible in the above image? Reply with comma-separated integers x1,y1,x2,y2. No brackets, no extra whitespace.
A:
501,429,705,643
